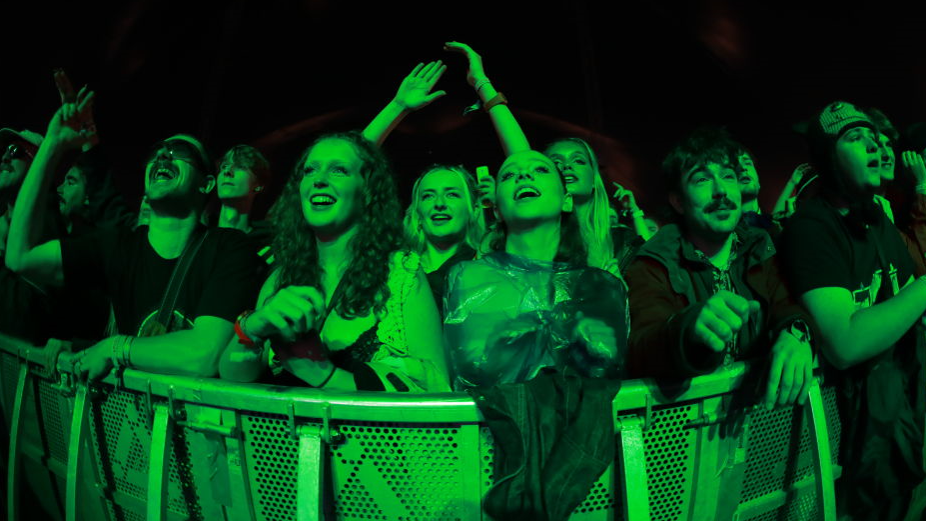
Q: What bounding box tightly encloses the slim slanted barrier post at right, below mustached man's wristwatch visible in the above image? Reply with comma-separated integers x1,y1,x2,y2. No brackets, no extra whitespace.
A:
804,379,836,521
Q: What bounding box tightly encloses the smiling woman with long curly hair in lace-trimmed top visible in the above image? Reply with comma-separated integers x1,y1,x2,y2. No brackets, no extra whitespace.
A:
220,132,447,391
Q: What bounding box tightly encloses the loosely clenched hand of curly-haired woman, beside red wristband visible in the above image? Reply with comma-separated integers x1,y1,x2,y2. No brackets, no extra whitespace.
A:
242,286,325,342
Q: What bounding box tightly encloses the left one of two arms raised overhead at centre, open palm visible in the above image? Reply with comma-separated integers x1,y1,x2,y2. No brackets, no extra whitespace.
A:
363,60,447,145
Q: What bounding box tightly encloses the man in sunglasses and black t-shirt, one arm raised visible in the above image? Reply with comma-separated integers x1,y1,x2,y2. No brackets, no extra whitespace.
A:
6,89,256,379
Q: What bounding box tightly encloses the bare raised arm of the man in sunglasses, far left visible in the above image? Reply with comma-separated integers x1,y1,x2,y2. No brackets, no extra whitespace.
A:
5,87,93,286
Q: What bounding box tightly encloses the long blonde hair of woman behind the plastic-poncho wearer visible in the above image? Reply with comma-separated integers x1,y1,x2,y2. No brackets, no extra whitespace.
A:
544,137,614,268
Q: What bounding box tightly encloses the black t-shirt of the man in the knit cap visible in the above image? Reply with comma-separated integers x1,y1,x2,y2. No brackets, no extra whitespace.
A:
779,198,913,302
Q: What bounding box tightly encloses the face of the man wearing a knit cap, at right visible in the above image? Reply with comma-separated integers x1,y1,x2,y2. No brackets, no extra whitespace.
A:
835,127,882,194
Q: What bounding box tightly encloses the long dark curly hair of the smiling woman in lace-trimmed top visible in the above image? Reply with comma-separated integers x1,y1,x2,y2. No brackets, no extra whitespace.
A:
270,132,404,319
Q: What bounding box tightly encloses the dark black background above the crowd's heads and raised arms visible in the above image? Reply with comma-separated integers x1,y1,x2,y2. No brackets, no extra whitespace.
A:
0,0,926,217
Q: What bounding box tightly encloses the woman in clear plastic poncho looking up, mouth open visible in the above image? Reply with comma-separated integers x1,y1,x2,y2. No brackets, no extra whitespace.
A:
444,150,628,390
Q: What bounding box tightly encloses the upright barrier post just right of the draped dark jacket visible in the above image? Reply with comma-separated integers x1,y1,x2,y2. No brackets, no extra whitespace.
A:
616,416,650,521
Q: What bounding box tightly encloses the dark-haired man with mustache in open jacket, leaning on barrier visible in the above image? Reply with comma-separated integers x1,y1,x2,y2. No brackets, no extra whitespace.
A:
625,128,813,408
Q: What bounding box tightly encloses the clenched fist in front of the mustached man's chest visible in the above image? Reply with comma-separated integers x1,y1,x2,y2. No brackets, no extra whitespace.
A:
689,290,759,353
